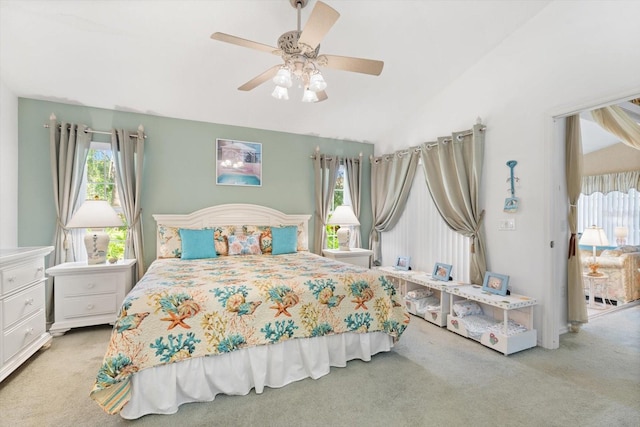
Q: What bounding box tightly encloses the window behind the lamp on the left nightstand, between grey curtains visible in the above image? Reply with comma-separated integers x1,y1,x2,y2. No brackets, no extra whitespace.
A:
80,141,127,259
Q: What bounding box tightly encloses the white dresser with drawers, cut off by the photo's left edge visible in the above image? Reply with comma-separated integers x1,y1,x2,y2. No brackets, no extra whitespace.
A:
0,246,53,381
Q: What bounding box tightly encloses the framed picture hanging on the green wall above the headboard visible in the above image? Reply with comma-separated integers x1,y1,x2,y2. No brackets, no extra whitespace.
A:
216,139,262,187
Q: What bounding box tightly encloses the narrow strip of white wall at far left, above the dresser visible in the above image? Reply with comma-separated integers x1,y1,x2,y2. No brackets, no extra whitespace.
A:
0,79,18,248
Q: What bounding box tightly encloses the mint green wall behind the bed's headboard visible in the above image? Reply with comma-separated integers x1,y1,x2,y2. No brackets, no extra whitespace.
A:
18,98,373,265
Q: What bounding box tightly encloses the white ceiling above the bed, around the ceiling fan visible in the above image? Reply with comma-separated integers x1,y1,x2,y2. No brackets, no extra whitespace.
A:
0,0,628,152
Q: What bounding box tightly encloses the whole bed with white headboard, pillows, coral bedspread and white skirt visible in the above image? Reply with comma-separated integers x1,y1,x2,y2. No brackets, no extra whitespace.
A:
91,204,409,419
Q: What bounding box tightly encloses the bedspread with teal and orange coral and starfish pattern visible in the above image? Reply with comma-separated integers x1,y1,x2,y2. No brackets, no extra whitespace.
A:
91,252,409,414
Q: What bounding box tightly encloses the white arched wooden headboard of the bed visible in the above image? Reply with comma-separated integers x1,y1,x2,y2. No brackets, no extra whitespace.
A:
153,203,311,256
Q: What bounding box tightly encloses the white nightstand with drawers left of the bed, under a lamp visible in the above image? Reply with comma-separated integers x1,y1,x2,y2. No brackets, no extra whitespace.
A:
47,259,136,337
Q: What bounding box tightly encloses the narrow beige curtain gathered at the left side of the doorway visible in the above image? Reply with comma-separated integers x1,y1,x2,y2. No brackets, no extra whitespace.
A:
565,115,588,332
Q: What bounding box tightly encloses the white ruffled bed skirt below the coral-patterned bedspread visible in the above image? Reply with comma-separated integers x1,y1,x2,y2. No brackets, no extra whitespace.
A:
120,332,393,419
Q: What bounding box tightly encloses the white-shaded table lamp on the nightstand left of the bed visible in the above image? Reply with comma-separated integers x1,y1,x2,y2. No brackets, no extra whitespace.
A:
67,197,124,264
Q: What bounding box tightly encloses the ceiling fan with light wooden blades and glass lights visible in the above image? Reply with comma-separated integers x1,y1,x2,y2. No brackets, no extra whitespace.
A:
211,0,384,102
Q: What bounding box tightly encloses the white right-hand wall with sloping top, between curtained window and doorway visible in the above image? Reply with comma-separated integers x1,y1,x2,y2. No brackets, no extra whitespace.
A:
376,1,640,348
